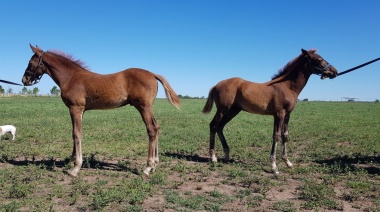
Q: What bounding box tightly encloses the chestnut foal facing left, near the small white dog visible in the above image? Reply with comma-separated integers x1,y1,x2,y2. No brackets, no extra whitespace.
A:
22,45,180,176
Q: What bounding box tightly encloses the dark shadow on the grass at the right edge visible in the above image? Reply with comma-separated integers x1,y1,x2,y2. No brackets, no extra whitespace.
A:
315,155,380,175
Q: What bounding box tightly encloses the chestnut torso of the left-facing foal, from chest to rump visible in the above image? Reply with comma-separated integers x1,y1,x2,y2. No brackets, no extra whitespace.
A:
61,68,158,110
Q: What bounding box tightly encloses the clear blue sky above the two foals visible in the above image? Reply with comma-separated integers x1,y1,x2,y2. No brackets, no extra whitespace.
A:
0,0,380,101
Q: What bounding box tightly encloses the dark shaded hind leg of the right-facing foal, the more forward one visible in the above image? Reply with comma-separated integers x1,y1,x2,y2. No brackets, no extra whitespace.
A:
217,107,241,162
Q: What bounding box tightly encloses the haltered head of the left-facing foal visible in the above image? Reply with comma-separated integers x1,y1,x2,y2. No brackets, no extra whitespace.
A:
22,44,46,86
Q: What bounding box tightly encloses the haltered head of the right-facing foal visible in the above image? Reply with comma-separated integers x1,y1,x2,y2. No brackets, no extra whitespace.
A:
302,49,338,79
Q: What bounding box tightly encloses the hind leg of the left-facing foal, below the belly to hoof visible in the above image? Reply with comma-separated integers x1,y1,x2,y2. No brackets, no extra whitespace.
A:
136,106,160,176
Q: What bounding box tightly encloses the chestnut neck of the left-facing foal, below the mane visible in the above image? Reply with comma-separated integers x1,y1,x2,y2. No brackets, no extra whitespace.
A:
43,53,75,87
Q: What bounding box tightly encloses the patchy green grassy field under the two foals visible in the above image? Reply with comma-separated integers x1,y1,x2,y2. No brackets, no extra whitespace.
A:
0,97,380,211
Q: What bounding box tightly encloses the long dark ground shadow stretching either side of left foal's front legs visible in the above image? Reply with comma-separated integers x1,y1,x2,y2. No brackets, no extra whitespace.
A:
5,156,140,175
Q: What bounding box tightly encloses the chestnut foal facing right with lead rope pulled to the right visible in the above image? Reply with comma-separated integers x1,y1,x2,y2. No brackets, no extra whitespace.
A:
203,49,338,174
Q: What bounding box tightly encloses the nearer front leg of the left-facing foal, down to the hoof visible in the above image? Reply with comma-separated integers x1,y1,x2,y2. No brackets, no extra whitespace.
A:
67,107,84,177
